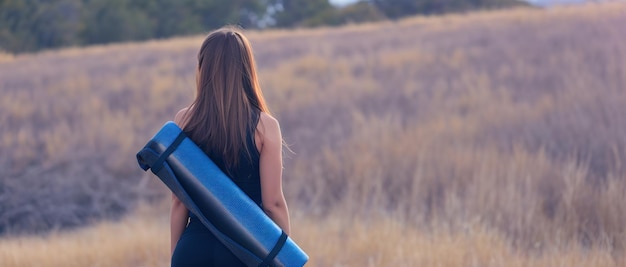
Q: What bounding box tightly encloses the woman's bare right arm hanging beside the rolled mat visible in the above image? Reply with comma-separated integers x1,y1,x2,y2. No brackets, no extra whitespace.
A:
259,113,290,234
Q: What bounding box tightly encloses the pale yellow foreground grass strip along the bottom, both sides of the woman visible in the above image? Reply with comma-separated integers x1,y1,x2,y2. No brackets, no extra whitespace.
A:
0,207,626,267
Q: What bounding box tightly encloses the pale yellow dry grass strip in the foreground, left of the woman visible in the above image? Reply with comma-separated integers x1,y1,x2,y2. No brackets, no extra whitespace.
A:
0,206,169,267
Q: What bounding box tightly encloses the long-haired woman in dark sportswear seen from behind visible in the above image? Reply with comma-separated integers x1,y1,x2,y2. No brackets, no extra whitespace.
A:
170,27,290,266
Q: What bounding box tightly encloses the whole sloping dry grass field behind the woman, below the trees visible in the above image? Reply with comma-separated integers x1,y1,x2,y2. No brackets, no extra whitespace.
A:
0,3,626,267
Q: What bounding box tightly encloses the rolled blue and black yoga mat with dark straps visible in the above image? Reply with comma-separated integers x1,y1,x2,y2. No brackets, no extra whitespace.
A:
137,121,309,267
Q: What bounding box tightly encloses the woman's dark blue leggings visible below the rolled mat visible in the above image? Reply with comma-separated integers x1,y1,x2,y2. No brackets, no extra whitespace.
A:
172,216,246,267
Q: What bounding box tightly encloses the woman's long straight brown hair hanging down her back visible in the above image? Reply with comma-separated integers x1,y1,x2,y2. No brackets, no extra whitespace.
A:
183,27,269,169
